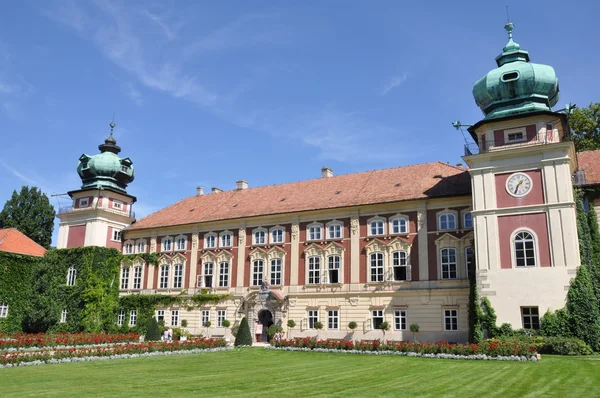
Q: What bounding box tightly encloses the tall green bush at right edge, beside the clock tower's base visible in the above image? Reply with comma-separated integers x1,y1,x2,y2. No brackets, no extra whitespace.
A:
567,265,600,352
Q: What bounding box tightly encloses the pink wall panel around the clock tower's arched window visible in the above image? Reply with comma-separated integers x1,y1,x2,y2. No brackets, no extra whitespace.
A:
498,213,552,269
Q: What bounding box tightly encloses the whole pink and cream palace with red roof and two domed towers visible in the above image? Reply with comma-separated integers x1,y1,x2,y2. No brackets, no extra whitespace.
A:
58,23,600,342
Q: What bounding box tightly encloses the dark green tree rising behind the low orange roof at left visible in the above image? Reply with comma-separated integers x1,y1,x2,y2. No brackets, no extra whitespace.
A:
0,186,56,248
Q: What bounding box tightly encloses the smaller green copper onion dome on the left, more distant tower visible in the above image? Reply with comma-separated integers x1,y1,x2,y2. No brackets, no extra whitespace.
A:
77,122,135,193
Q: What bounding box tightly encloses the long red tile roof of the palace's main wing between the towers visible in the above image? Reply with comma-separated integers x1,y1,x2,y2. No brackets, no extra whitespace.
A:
128,162,471,231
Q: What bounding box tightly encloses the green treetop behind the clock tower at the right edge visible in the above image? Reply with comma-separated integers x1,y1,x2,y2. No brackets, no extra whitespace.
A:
569,102,600,152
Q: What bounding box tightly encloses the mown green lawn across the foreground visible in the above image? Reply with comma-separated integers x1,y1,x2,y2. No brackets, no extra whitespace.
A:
0,348,600,398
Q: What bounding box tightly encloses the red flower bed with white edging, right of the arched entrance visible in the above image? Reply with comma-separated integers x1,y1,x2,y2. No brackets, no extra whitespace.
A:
271,338,537,358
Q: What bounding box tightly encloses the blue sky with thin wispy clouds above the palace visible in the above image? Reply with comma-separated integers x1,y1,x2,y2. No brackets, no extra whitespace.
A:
0,0,600,246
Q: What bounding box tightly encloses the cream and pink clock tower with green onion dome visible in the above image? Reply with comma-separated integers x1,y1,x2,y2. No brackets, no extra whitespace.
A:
464,23,580,328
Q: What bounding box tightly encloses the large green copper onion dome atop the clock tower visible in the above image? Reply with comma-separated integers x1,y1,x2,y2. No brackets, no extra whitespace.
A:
473,22,559,119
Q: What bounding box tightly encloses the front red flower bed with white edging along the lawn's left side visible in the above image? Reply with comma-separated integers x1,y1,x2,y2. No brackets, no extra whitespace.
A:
0,339,227,367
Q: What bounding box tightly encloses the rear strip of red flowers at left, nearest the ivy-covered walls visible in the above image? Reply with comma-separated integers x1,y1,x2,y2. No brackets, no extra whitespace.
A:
0,333,140,351
